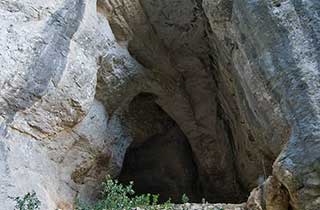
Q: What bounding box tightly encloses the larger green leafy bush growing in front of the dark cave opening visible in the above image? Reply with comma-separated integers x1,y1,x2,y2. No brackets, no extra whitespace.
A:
76,177,185,210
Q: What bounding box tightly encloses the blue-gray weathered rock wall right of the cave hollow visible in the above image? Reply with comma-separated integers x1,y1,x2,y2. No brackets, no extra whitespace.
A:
203,0,320,209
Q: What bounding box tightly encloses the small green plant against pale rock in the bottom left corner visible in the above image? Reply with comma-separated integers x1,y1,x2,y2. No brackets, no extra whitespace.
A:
13,191,41,210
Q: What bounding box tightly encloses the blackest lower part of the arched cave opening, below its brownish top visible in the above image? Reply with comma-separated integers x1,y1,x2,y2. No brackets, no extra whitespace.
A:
119,125,199,203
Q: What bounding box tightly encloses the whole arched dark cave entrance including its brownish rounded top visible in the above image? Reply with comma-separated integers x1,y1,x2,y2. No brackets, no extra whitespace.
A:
118,93,199,203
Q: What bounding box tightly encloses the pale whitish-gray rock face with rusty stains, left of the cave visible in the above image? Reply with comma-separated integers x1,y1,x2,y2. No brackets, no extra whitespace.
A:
0,0,142,210
